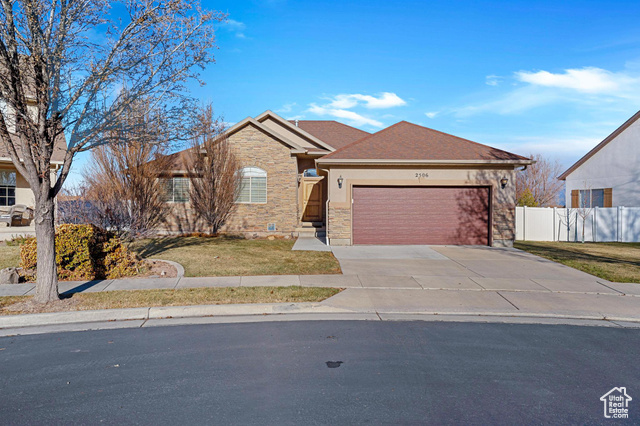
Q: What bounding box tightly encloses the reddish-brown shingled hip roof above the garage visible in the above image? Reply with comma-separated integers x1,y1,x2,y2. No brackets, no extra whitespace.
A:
318,121,532,165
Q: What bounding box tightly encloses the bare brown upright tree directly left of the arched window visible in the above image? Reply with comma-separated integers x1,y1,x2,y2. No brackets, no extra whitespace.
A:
185,105,241,235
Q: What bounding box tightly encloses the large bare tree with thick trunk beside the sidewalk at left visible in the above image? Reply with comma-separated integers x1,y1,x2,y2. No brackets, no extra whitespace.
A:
0,0,226,303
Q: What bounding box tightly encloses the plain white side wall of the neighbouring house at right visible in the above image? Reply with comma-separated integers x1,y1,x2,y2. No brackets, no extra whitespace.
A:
565,121,640,207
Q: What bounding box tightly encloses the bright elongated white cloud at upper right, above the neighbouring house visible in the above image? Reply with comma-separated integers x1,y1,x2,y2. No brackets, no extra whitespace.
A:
515,67,640,95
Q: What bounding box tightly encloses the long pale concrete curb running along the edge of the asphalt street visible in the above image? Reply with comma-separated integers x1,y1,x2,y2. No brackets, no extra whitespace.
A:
0,302,640,330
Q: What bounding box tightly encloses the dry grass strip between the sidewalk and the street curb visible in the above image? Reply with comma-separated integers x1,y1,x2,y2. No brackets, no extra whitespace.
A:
0,286,342,315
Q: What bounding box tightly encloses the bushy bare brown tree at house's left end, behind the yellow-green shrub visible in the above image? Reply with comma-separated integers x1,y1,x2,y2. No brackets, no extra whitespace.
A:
83,99,170,237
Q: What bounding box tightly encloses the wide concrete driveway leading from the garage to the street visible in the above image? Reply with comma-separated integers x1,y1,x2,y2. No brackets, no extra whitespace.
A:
323,246,640,321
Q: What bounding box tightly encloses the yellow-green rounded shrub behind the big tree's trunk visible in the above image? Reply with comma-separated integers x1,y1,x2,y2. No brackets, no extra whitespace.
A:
20,225,140,280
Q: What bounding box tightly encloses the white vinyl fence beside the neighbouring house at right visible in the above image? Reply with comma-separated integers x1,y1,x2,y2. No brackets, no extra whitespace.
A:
516,207,640,242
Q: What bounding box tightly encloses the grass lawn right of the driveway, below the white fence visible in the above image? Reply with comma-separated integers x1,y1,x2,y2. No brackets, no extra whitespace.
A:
514,241,640,283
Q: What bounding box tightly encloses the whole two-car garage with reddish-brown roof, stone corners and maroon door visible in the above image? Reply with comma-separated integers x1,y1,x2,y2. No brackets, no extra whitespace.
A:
316,121,533,247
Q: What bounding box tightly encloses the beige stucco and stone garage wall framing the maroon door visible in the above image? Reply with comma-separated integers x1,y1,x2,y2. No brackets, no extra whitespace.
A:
327,166,515,246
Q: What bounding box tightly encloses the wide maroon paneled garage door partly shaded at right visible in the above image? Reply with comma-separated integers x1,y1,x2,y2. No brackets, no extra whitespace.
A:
353,186,489,245
